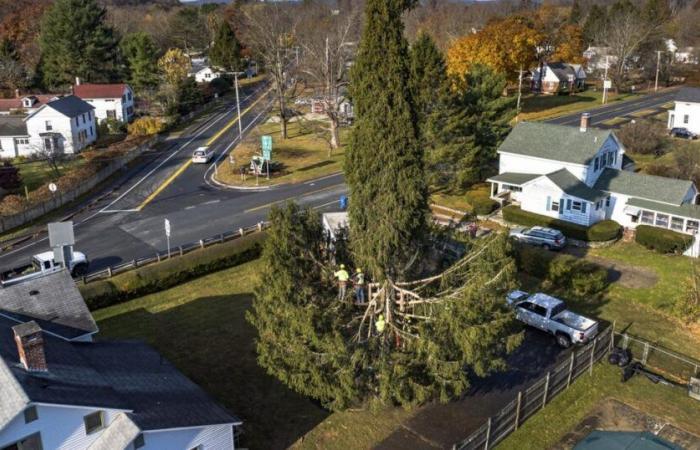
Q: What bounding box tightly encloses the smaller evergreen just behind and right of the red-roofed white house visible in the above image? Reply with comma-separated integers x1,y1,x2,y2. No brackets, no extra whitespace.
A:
120,31,159,90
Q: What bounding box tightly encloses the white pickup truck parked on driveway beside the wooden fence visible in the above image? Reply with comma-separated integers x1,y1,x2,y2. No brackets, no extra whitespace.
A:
506,291,598,348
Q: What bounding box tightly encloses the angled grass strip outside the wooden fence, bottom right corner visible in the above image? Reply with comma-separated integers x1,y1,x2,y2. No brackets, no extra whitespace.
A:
496,362,700,450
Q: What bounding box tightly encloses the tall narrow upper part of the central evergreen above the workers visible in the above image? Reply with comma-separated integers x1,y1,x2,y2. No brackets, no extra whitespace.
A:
345,0,427,279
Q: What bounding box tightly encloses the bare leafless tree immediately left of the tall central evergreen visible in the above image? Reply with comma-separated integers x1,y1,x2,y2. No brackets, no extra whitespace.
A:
298,3,361,155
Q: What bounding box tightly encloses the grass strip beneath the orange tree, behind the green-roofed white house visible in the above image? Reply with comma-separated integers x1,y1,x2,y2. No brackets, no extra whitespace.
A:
519,89,638,120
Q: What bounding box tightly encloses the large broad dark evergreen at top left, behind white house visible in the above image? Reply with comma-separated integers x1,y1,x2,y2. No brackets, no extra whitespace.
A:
39,0,117,87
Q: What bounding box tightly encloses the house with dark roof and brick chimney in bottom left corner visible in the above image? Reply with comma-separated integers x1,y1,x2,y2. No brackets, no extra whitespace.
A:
0,271,241,450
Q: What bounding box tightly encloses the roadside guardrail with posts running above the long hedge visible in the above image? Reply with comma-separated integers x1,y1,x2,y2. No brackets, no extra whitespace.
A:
81,222,269,283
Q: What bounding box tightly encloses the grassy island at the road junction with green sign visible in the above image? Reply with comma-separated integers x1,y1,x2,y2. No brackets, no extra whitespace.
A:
217,121,350,186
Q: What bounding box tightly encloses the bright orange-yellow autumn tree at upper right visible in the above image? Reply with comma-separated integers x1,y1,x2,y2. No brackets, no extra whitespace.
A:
447,16,541,80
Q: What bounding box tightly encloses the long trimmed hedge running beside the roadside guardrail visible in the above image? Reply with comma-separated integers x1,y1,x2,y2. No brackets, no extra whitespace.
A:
78,232,266,310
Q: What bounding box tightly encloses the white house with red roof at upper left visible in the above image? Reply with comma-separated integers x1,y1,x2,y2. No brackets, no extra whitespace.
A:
73,78,134,122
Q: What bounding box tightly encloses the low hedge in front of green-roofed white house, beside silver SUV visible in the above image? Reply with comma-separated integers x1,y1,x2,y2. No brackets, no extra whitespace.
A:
503,205,622,242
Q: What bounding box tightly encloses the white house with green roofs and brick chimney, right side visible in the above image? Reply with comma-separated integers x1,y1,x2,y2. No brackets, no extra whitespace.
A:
488,114,700,244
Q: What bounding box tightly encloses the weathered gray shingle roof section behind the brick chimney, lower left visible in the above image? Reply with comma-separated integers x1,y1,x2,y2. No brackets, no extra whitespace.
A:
0,270,98,340
